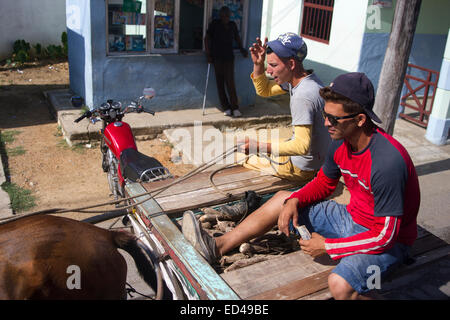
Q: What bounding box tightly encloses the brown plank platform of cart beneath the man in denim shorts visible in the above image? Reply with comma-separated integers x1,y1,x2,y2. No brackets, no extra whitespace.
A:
221,228,450,300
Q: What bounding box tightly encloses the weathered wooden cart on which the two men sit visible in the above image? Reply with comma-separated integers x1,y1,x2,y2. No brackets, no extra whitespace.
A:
125,167,450,300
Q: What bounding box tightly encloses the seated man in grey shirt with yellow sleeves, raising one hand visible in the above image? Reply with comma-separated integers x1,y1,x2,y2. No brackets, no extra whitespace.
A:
240,33,330,182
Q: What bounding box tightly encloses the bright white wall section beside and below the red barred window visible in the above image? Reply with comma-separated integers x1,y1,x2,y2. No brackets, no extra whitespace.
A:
305,0,368,72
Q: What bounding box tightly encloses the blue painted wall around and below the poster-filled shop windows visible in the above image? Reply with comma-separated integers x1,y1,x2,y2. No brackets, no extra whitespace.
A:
66,0,262,111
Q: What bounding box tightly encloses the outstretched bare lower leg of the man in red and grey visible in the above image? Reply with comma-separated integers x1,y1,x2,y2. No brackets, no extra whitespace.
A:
215,191,291,256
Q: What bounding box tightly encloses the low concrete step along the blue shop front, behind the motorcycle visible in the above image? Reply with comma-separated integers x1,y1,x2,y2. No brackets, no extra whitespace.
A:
44,89,291,145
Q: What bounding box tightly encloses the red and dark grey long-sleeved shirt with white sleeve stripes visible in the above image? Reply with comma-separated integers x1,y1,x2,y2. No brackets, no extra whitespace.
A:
288,128,420,259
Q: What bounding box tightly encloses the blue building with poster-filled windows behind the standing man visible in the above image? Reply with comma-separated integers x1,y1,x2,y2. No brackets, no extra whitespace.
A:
66,0,262,111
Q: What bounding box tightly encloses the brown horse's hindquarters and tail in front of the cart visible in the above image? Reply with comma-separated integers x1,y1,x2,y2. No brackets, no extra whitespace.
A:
0,215,171,299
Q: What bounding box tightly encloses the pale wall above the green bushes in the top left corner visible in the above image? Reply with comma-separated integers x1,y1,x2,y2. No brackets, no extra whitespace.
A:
0,0,66,59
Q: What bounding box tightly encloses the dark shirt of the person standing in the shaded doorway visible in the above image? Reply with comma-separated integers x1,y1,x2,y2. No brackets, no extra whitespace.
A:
206,19,238,60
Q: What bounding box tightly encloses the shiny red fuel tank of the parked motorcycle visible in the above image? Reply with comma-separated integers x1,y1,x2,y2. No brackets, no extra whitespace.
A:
103,121,137,159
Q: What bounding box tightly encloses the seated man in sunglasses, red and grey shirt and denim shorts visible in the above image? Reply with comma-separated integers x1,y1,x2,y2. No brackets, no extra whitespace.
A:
183,72,420,299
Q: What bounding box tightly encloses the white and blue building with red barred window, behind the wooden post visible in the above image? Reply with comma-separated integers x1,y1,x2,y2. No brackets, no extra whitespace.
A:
261,0,450,144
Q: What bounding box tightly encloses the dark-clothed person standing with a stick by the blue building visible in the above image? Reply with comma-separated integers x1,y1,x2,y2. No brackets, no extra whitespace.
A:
205,6,248,117
